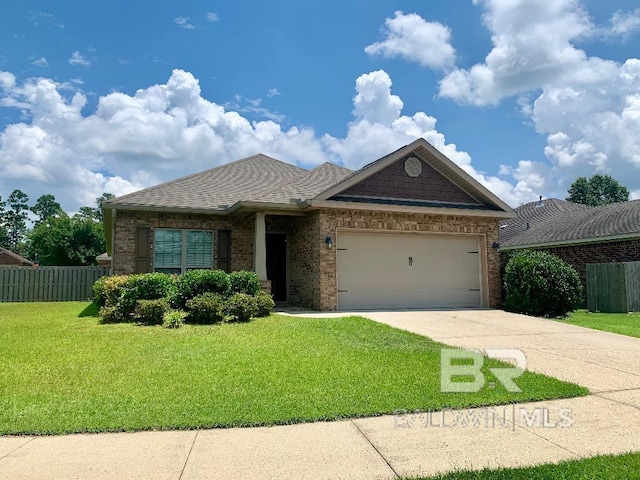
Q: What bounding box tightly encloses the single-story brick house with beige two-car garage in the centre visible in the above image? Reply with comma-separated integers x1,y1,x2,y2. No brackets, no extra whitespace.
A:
103,139,515,310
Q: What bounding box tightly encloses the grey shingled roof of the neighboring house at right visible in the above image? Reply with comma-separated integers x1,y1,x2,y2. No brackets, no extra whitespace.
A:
500,198,640,250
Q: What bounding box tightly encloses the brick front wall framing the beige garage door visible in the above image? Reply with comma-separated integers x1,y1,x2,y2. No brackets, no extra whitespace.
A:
313,209,502,310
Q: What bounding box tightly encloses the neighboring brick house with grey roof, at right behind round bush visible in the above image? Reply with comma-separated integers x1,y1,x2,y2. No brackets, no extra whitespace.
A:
500,198,640,295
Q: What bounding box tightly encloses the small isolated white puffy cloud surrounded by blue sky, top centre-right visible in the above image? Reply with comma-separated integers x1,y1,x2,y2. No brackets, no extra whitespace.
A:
364,11,456,69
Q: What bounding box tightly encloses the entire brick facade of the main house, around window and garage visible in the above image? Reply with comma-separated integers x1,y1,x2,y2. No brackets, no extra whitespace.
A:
113,209,501,310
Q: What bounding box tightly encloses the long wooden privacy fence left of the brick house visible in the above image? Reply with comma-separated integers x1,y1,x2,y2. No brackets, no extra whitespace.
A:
0,267,109,302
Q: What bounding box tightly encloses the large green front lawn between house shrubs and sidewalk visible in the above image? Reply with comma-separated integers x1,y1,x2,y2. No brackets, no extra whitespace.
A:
0,302,588,435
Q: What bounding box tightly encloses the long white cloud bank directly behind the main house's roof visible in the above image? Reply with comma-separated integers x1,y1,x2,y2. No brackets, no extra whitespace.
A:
0,70,528,211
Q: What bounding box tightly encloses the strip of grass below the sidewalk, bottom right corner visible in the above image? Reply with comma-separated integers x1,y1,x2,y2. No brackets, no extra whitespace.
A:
424,453,640,480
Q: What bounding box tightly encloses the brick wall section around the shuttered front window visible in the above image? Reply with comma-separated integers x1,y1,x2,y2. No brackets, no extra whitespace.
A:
113,210,255,275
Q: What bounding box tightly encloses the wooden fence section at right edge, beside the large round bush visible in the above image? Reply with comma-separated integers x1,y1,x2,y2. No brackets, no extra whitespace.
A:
587,262,640,313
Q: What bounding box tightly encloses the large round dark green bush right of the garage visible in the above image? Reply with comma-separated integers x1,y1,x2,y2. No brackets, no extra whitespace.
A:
504,250,582,317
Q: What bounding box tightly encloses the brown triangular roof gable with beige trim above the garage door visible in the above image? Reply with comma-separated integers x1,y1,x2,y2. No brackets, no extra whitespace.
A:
314,138,513,214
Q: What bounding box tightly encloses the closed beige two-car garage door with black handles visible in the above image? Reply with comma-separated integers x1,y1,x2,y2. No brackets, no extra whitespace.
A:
336,232,482,310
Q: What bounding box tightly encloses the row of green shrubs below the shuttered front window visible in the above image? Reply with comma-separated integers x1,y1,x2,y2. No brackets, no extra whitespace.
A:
93,270,274,328
